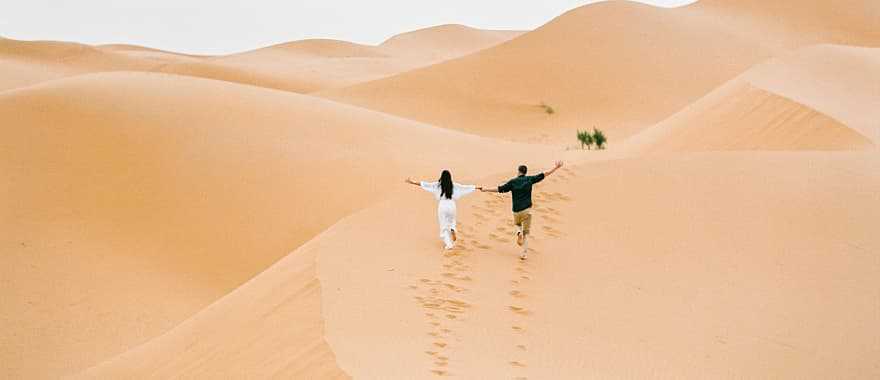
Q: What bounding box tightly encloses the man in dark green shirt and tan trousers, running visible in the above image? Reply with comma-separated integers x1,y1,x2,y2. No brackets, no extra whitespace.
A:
479,161,562,260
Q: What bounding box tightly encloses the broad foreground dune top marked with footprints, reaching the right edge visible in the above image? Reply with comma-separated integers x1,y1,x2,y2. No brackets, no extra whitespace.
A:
310,152,880,379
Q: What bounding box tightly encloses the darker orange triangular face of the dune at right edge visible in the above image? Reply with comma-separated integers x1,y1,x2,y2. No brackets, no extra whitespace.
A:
630,81,874,152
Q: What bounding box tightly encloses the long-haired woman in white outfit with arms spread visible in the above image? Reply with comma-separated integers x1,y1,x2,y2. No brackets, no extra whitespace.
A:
406,170,477,249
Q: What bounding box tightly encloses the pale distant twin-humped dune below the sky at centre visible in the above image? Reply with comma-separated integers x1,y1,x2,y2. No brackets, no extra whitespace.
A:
162,25,520,93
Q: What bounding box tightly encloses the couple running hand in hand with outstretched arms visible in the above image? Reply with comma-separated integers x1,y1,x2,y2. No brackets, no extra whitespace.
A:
406,161,562,260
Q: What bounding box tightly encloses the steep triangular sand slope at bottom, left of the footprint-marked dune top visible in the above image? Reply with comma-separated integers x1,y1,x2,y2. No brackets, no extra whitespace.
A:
76,248,347,379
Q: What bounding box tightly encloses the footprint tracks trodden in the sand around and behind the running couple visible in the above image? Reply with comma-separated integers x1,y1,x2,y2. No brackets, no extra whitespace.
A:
409,168,574,379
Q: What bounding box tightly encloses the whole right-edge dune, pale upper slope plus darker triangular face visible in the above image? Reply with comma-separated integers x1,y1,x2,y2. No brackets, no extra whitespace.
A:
623,45,880,154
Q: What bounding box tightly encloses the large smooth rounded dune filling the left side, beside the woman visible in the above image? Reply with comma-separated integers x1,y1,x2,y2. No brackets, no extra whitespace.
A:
0,72,546,378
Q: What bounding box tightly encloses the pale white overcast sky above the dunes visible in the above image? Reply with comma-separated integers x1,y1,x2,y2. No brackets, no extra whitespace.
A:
0,0,694,54
